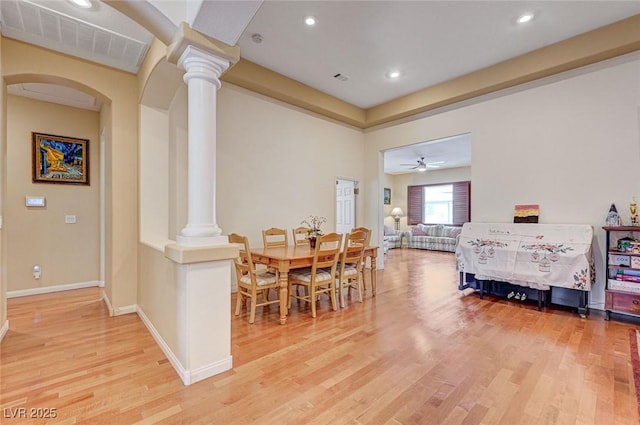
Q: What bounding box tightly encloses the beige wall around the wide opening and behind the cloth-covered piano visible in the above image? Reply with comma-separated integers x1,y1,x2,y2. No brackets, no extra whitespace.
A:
365,55,640,309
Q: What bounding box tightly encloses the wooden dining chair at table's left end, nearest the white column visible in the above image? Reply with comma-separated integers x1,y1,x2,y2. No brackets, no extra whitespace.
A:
229,233,280,323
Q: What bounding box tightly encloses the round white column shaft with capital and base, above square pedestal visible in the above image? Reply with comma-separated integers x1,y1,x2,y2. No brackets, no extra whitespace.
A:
176,46,229,246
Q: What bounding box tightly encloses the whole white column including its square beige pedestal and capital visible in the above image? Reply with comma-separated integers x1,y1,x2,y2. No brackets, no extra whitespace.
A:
165,43,238,385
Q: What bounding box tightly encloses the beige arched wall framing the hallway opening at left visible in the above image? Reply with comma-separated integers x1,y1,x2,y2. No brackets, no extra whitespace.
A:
1,38,138,314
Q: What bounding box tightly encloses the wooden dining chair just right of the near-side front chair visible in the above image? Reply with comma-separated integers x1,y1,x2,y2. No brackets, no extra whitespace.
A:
335,230,367,307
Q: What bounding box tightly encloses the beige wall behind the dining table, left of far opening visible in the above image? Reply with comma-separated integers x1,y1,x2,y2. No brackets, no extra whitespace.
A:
217,84,364,246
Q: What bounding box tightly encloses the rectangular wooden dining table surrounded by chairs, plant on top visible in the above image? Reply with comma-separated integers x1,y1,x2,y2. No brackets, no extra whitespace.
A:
251,245,378,325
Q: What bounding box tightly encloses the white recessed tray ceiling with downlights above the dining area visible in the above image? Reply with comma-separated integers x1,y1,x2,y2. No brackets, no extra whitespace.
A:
239,1,640,108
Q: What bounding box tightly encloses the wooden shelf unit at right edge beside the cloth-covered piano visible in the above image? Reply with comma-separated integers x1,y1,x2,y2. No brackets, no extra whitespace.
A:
603,226,640,320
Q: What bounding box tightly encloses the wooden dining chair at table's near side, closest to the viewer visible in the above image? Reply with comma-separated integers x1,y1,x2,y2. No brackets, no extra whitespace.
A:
289,233,342,317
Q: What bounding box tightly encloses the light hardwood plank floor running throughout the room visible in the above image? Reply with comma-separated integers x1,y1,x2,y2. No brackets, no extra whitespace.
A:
0,249,638,425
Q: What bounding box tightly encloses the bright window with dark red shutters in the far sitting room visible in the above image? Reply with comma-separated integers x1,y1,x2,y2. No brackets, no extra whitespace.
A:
407,181,471,225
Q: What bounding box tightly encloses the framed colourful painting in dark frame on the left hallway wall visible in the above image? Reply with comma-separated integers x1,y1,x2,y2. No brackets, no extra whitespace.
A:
31,133,89,185
